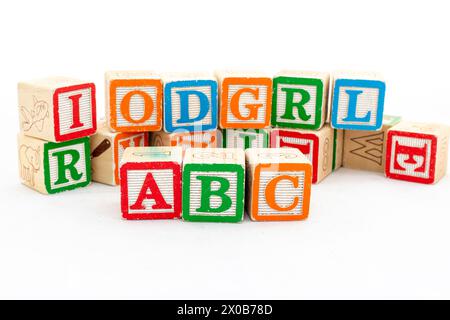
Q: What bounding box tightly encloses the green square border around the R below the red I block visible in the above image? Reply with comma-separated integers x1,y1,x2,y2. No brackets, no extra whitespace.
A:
44,137,91,194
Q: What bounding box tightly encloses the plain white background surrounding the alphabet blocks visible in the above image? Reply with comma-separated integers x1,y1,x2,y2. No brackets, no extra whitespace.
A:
0,0,450,299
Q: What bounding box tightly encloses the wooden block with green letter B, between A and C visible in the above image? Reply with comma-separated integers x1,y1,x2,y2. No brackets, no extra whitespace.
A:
183,148,245,222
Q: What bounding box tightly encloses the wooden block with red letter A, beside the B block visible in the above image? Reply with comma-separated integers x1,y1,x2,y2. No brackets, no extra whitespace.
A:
120,147,182,220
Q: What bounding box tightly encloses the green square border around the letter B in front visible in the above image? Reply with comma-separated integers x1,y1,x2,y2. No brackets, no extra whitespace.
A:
182,163,245,223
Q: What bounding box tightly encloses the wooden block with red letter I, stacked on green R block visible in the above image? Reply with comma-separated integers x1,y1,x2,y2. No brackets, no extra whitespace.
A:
18,77,97,142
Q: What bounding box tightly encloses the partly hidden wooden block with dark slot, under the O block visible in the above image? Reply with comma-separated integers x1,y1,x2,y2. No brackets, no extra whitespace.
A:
90,122,149,186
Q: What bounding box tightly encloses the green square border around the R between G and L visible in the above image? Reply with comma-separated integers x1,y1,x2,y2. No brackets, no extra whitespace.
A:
271,77,324,130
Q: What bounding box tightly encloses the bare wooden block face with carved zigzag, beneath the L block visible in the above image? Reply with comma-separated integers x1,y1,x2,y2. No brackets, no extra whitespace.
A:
342,115,401,172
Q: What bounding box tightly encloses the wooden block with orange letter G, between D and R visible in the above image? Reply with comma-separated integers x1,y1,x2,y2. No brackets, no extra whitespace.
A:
217,72,272,129
